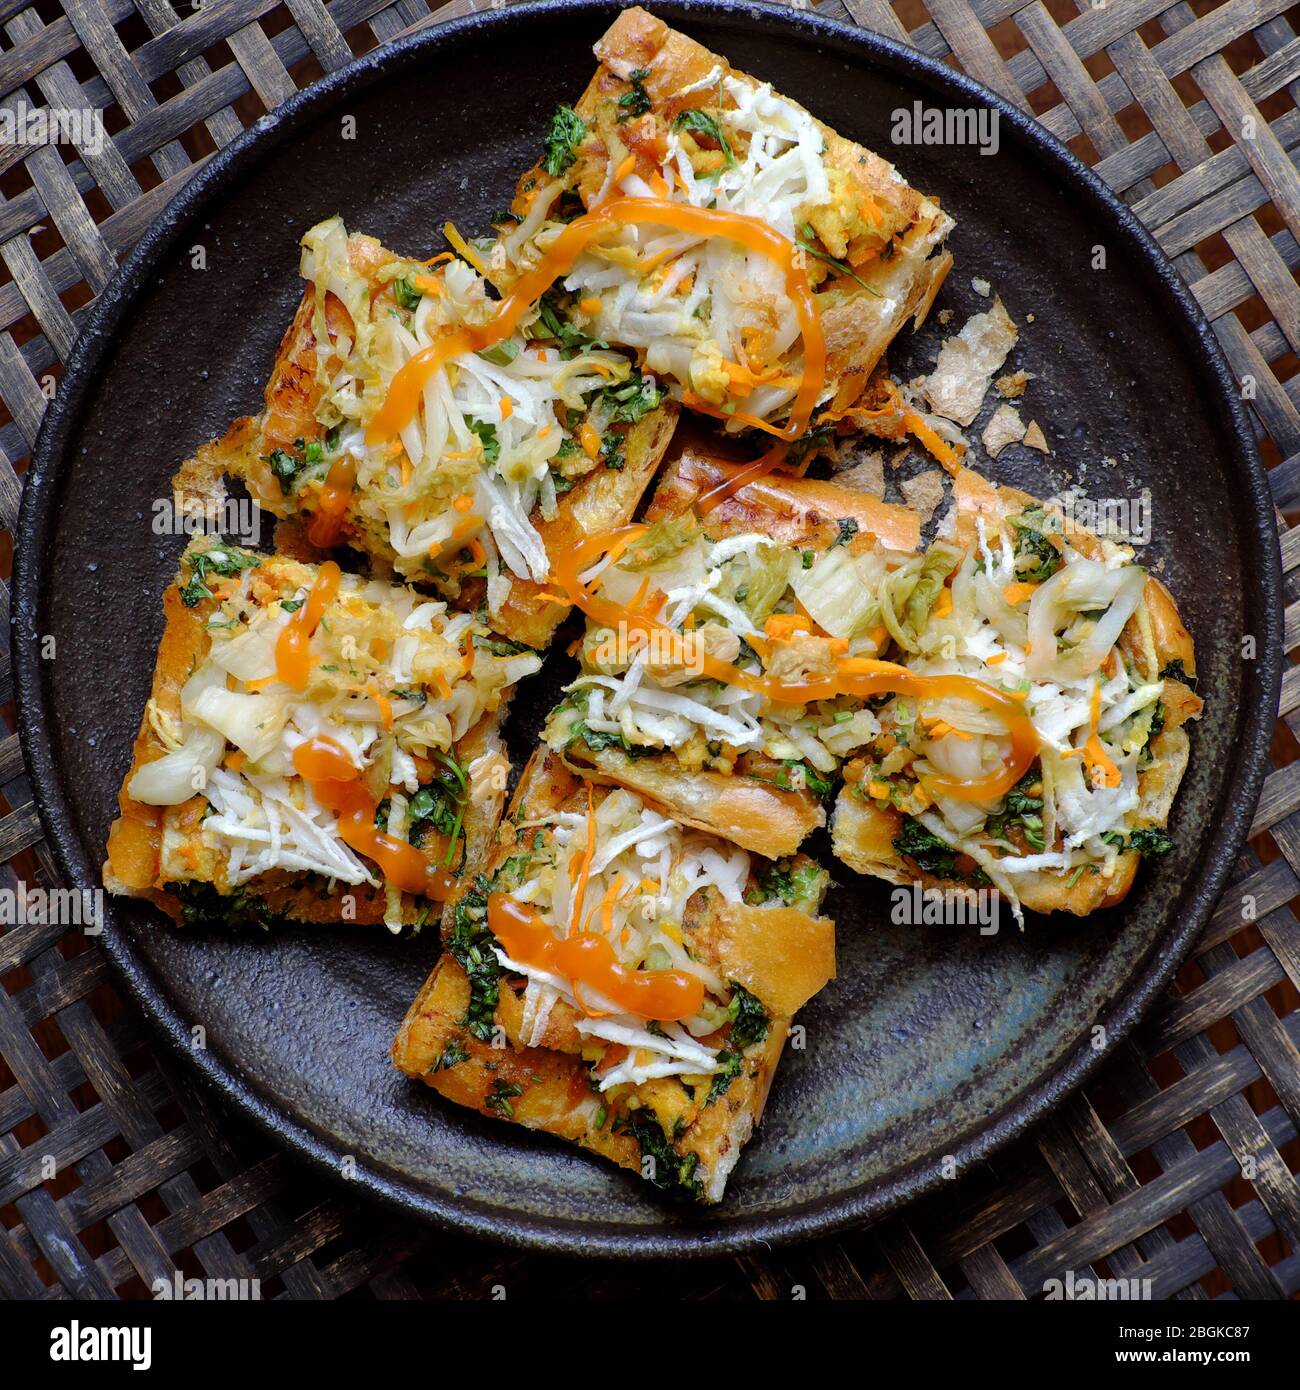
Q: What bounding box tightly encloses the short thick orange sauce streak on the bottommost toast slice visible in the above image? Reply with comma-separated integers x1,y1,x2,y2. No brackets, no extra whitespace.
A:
488,892,704,1022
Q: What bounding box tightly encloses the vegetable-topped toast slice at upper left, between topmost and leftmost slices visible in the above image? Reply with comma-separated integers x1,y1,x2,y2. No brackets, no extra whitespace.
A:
209,217,676,646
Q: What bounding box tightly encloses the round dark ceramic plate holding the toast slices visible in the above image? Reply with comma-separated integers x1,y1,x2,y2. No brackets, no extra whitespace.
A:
14,3,1281,1255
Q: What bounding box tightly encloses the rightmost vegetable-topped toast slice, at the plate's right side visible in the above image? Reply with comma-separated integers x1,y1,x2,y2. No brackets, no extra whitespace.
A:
833,470,1201,916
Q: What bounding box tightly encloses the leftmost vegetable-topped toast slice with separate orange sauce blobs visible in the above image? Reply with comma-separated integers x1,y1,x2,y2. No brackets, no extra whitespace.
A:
104,537,541,931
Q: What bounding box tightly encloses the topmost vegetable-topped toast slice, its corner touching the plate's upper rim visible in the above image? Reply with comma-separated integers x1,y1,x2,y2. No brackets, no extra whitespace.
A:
492,7,954,432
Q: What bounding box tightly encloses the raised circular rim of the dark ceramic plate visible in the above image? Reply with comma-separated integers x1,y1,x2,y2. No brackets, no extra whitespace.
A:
10,0,1282,1259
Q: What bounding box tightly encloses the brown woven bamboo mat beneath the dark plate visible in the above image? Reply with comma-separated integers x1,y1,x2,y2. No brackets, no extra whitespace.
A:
0,0,1300,1298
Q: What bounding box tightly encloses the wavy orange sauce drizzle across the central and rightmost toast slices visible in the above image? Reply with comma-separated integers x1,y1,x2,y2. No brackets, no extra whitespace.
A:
553,525,1039,801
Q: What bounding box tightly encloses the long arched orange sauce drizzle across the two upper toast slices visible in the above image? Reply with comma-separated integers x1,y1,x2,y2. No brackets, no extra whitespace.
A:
364,197,826,512
